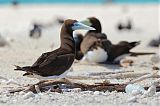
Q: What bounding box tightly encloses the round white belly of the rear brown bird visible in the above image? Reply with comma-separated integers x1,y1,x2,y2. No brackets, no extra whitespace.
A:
82,47,108,63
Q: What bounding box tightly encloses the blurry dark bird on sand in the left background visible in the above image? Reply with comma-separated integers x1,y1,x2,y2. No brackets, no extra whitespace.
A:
29,23,42,39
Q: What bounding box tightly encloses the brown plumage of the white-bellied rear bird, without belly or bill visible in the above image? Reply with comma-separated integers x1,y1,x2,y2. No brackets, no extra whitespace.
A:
80,17,155,63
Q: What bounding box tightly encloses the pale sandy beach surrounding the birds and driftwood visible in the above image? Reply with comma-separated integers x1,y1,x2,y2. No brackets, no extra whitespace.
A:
0,4,160,106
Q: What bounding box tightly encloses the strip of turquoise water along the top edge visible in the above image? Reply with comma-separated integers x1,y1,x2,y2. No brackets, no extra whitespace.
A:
0,0,160,4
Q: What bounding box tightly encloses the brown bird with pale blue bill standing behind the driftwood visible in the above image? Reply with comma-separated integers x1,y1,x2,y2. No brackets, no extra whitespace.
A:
14,19,95,80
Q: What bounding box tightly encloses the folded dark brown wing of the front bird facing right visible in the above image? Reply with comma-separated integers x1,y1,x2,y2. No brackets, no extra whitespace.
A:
36,53,75,76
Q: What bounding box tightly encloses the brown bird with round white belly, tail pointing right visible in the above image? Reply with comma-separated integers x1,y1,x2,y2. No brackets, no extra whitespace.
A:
80,17,155,63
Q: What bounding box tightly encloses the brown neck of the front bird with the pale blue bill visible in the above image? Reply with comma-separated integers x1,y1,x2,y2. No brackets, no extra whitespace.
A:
60,24,75,53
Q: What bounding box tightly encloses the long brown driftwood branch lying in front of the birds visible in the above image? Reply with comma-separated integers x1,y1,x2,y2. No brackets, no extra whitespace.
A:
10,79,160,93
